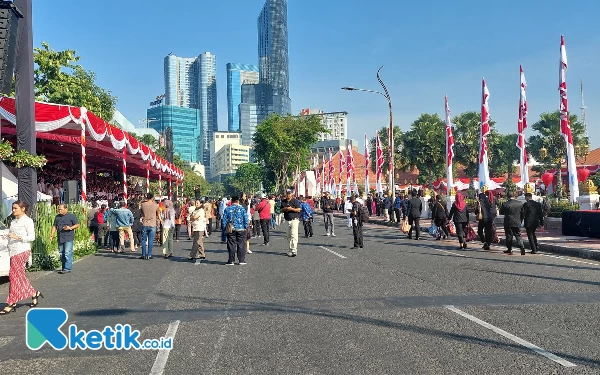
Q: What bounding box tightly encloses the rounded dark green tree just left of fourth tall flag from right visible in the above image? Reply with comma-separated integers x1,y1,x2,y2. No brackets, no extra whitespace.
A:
402,113,446,184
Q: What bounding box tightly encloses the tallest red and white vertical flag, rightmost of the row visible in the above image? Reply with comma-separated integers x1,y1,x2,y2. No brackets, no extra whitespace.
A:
558,35,579,202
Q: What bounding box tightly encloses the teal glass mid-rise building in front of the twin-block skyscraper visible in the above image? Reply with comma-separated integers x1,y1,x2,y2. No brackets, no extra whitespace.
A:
147,105,202,163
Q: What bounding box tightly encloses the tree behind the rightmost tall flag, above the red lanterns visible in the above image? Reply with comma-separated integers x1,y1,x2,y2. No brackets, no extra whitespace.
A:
527,111,589,172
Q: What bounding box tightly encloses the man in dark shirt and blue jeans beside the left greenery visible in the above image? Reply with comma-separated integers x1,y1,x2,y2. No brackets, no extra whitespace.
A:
50,204,79,274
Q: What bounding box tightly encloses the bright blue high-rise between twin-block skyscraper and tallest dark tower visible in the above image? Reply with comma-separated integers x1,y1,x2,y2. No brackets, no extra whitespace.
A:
227,63,258,132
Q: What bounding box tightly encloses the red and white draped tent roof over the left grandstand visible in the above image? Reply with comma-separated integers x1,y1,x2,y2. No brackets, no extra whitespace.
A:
0,97,183,179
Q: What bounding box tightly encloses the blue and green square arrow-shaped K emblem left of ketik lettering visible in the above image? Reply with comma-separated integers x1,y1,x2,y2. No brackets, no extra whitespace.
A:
25,308,69,350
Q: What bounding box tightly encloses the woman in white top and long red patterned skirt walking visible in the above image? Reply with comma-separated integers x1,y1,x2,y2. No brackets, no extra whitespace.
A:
0,200,43,315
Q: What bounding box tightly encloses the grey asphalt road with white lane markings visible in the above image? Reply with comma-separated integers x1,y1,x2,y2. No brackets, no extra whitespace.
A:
0,219,600,374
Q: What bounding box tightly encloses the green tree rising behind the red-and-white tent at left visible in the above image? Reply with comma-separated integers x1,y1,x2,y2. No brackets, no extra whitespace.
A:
33,42,117,121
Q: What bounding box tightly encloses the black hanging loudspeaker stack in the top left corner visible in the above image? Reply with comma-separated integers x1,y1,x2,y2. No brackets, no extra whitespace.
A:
0,1,23,95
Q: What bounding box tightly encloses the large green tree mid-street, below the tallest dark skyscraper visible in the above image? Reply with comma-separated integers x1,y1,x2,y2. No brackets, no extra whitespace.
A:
252,114,329,192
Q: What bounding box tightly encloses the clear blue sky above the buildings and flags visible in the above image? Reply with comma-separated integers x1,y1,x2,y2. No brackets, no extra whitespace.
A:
33,0,600,148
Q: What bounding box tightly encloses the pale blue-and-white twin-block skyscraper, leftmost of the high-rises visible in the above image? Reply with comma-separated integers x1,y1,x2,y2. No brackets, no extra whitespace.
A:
164,52,219,176
